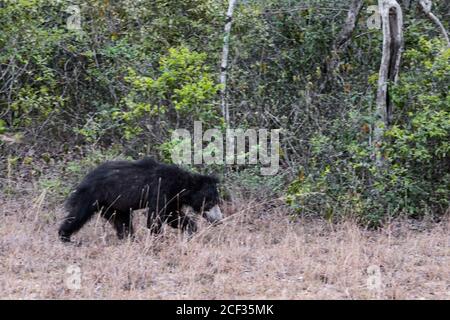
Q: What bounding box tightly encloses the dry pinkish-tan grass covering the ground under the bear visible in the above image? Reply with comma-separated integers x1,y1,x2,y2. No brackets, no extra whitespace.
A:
0,190,450,299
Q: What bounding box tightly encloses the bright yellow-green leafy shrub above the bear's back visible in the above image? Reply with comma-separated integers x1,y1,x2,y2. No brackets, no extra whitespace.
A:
113,47,223,152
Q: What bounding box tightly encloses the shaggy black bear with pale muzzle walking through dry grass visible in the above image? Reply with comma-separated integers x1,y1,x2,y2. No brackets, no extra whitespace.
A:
59,158,222,242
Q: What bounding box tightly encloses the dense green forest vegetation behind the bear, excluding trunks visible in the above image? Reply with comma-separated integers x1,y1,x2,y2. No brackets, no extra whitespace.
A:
0,0,450,224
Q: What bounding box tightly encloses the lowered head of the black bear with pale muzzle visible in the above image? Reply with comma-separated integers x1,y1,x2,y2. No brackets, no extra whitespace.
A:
186,174,223,223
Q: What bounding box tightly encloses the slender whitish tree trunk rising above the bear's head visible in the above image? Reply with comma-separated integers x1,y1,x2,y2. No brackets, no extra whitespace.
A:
220,0,237,127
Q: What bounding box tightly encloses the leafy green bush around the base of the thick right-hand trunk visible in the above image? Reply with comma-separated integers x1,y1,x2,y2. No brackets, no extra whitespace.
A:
287,37,450,225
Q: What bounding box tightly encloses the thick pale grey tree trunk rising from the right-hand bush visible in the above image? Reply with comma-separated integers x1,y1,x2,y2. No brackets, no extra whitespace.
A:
374,0,403,167
